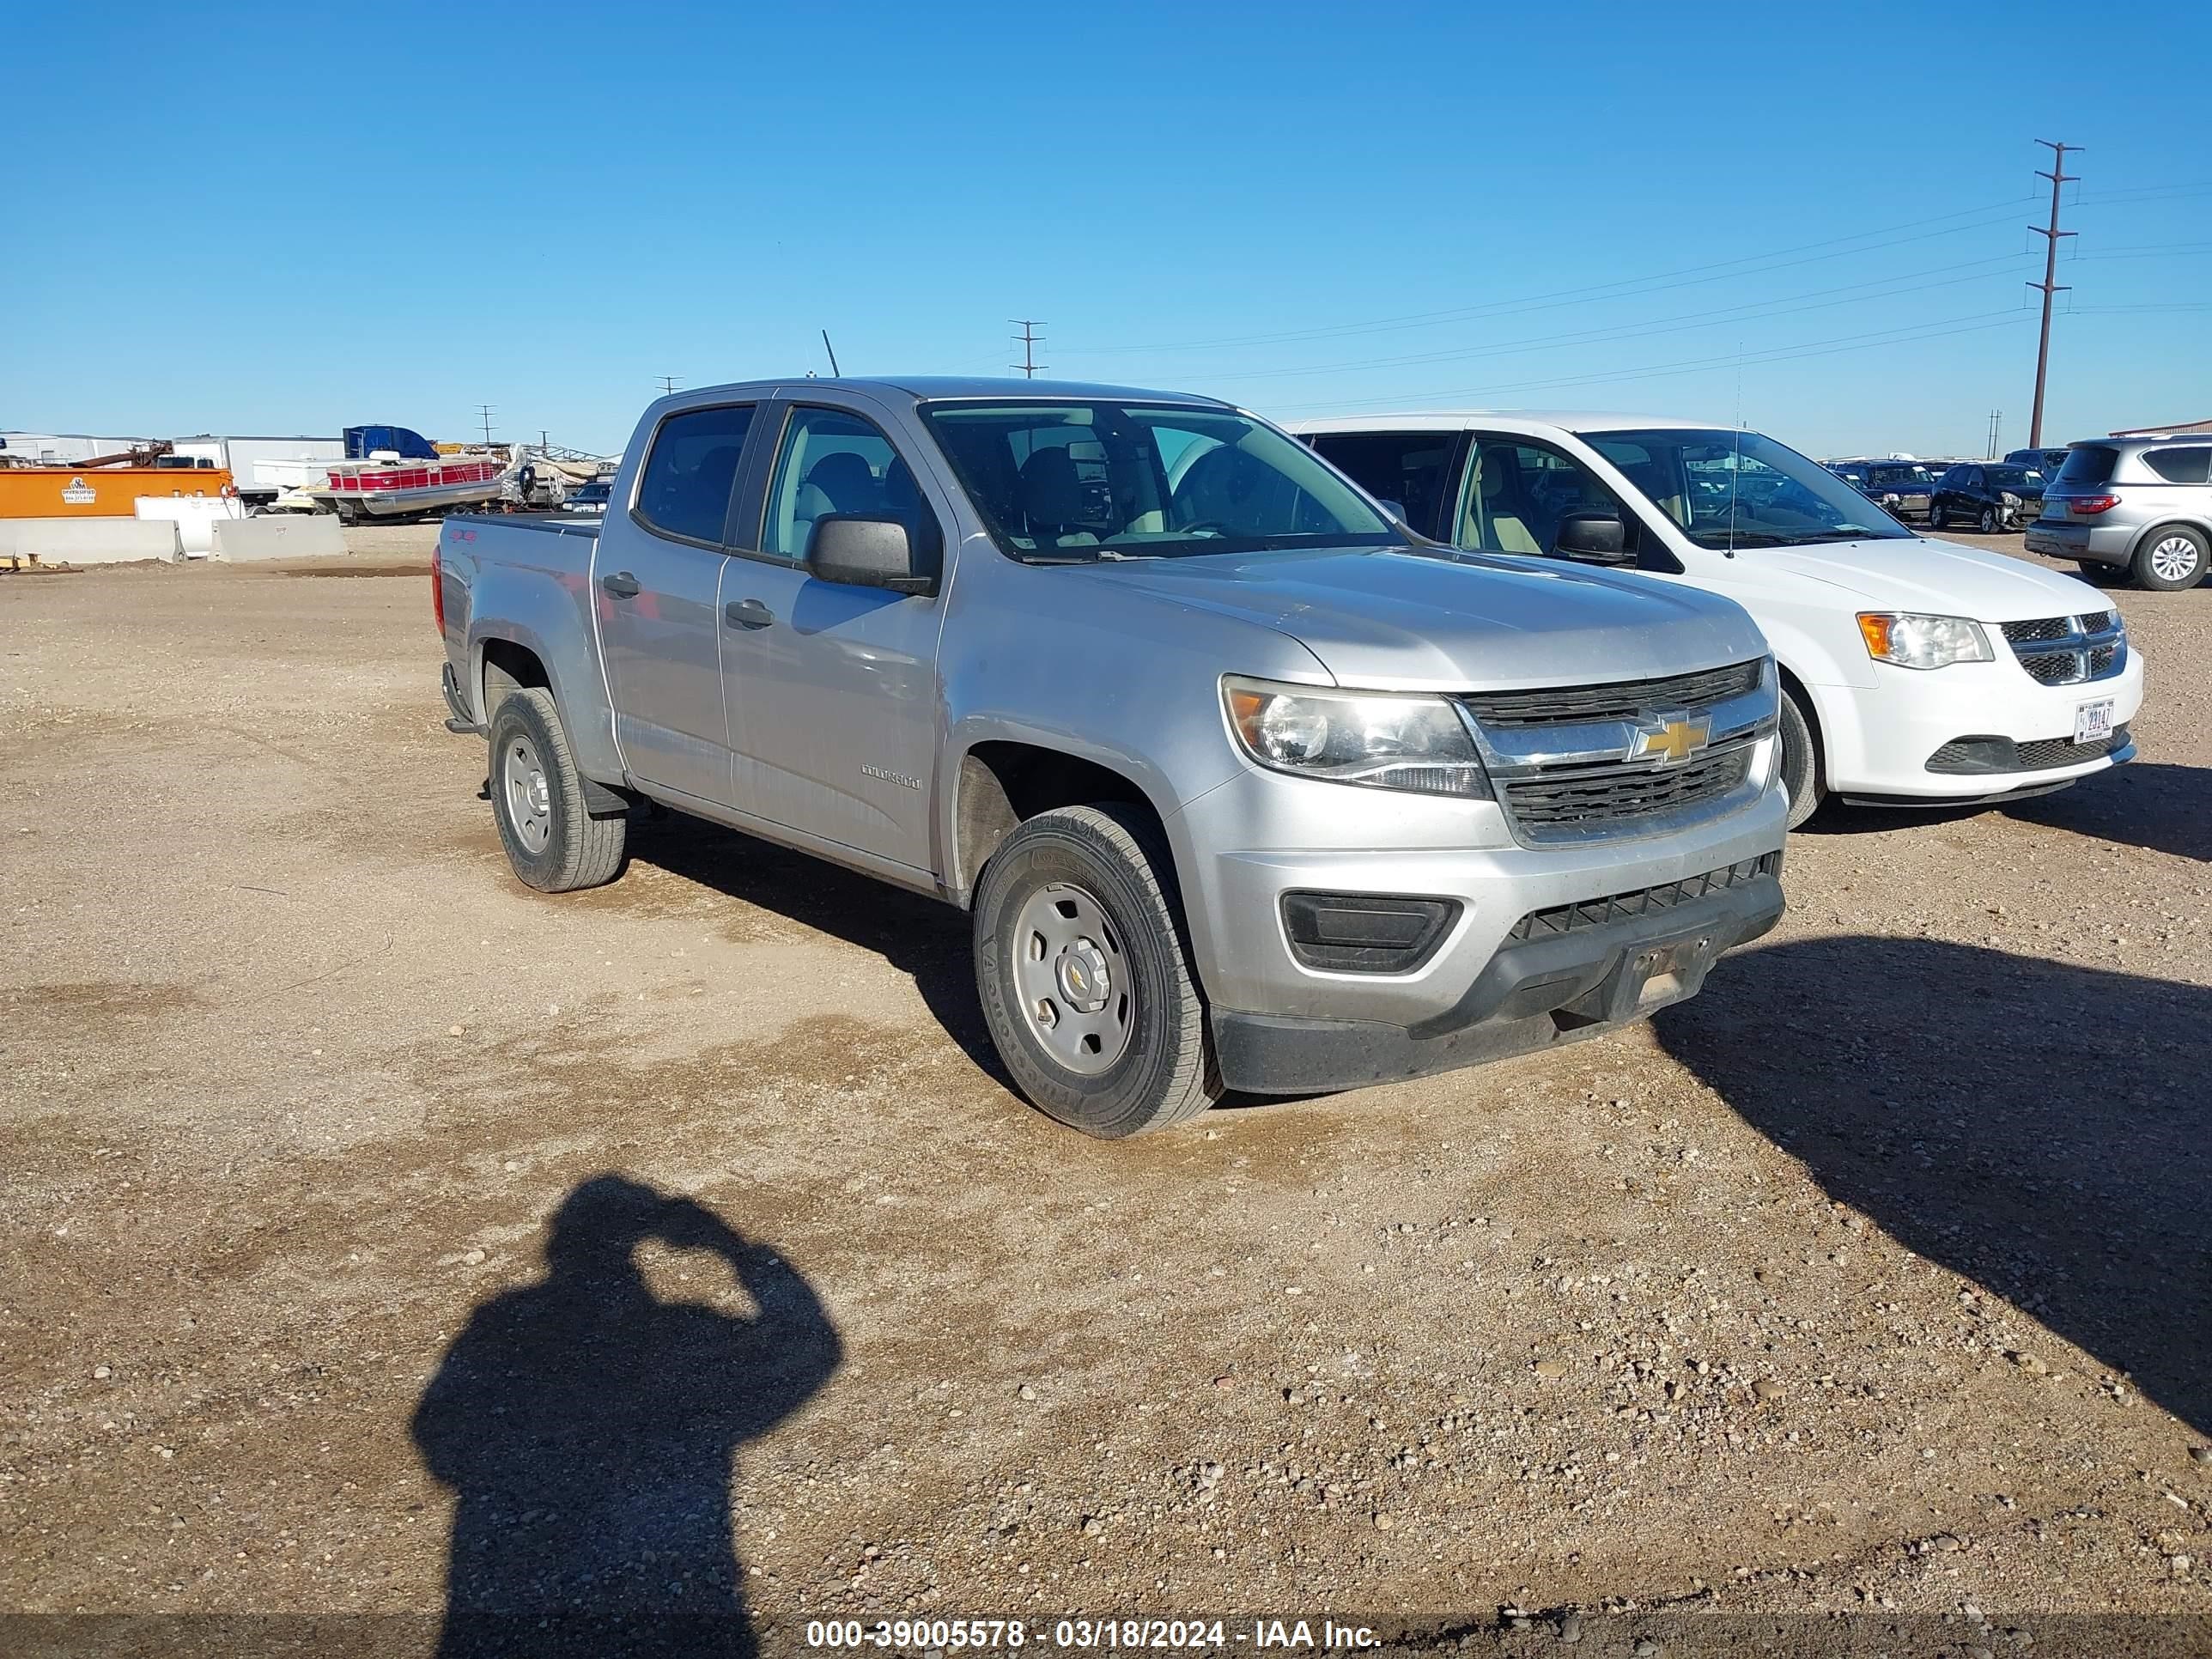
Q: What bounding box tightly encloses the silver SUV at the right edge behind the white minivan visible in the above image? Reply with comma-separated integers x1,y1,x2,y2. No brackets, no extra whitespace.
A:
2027,435,2212,592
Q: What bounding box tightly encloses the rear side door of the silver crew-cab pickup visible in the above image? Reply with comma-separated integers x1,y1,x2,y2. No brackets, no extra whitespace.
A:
591,403,754,805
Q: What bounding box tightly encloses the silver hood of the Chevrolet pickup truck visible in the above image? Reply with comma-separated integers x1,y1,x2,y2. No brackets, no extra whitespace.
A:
1082,549,1767,690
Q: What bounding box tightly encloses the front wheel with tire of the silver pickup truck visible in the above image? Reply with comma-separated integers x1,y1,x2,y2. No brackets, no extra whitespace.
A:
975,803,1224,1139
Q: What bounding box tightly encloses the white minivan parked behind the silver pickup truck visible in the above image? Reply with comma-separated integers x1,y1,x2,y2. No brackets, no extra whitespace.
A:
1290,411,2143,825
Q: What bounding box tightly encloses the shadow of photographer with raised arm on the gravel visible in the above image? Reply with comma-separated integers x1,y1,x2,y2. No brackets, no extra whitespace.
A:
411,1175,842,1659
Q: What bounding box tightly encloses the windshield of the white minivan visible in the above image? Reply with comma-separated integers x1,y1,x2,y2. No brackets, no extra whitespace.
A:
1582,427,1911,550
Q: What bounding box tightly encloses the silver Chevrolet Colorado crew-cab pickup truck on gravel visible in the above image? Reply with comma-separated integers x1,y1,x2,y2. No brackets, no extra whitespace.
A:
434,378,1785,1137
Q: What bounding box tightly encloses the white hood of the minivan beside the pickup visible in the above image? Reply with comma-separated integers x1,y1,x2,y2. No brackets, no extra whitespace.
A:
1736,535,2112,622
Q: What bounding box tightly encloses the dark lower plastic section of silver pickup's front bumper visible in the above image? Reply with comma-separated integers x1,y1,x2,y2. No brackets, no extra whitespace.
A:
1210,854,1783,1095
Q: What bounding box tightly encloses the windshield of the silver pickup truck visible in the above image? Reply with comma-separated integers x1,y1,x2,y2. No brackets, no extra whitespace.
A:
922,398,1407,564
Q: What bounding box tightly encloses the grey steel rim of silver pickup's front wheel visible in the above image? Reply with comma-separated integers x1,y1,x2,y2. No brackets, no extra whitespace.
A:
1013,880,1137,1078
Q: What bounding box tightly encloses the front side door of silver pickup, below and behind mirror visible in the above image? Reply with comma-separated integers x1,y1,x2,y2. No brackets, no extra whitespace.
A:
721,403,949,876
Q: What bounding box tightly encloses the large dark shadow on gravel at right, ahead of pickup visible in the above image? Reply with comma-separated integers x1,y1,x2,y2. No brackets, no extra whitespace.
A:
1652,936,2212,1431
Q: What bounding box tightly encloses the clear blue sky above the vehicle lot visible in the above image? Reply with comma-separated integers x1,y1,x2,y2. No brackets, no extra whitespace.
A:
0,0,2212,453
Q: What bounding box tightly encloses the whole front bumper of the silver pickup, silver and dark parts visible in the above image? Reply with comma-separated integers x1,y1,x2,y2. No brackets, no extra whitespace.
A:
1168,769,1787,1093
